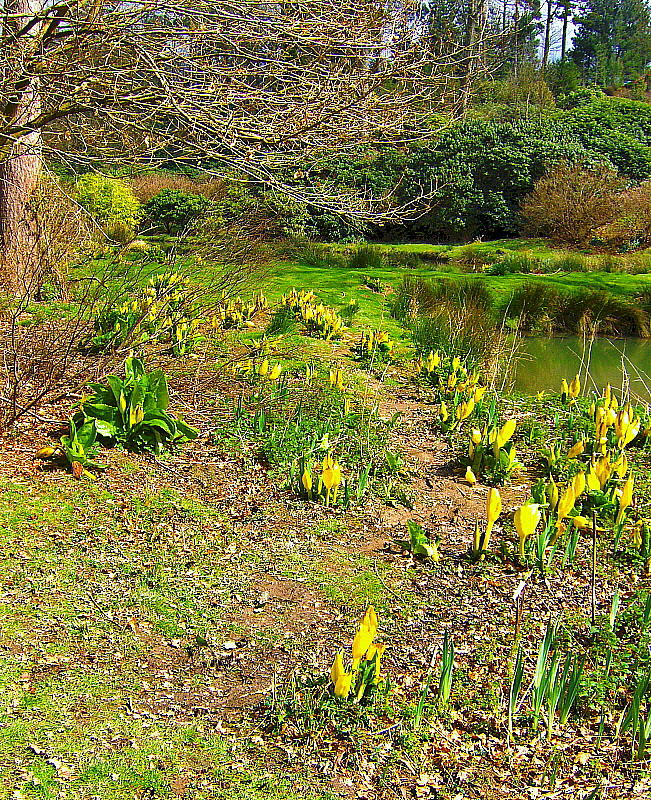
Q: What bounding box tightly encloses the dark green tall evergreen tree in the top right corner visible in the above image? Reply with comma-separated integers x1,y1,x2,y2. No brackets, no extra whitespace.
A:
570,0,651,85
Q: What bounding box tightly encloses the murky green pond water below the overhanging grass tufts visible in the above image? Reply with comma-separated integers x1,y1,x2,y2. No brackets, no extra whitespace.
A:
514,337,651,401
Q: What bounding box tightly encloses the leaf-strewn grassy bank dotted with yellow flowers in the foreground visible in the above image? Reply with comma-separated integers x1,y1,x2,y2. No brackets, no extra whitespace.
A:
0,238,651,800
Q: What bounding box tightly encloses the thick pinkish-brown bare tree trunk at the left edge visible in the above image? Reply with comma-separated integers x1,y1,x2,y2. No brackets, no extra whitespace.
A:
0,0,41,295
